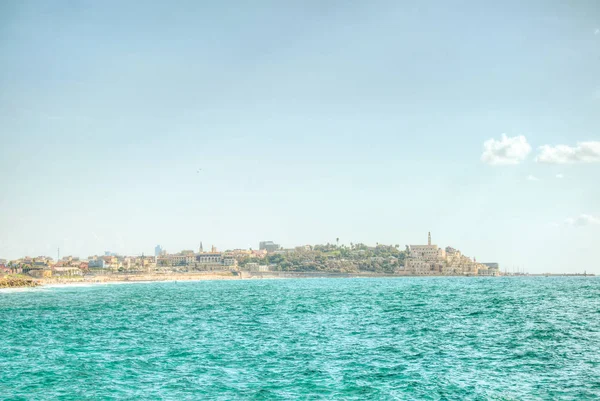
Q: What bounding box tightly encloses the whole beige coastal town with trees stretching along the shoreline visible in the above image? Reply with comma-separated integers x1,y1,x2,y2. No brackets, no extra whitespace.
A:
0,234,500,278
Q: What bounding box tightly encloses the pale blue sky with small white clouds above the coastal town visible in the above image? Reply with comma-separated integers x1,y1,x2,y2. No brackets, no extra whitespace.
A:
0,0,600,274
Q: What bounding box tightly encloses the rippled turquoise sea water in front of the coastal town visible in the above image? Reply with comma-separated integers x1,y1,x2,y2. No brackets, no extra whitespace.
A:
0,277,600,400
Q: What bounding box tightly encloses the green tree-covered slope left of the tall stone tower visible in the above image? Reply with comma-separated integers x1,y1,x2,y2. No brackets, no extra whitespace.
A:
238,244,406,273
